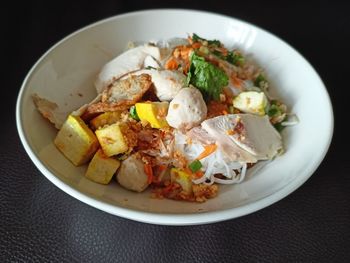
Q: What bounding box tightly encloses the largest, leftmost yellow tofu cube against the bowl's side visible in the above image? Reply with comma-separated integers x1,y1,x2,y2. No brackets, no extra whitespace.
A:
54,115,99,166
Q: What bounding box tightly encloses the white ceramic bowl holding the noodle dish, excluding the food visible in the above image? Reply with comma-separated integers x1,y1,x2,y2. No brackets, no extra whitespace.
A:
16,10,333,225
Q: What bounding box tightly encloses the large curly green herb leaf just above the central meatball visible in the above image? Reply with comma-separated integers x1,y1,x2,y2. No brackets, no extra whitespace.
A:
187,52,228,100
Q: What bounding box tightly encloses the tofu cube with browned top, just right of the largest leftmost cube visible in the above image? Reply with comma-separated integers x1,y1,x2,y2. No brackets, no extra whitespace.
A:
95,123,129,157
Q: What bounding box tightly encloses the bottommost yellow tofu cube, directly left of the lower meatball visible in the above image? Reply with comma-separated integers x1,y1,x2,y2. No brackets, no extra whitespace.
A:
85,149,120,184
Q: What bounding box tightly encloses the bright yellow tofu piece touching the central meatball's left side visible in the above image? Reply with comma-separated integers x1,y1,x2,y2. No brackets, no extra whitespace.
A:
135,101,169,128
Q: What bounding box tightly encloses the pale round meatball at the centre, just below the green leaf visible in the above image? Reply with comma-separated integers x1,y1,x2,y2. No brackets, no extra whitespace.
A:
166,88,207,130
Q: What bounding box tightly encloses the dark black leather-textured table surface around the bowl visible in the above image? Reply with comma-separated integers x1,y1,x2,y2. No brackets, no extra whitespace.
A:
0,0,350,262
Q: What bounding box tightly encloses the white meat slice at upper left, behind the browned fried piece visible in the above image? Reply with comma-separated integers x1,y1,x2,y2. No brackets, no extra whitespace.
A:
95,45,161,93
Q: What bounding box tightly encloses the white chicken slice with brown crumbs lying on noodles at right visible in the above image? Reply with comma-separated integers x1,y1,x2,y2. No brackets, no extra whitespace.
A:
202,114,283,160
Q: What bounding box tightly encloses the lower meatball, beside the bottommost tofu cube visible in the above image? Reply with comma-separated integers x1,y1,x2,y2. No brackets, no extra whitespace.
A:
117,155,149,192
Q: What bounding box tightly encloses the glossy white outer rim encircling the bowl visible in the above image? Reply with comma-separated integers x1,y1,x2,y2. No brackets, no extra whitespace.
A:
16,8,334,225
